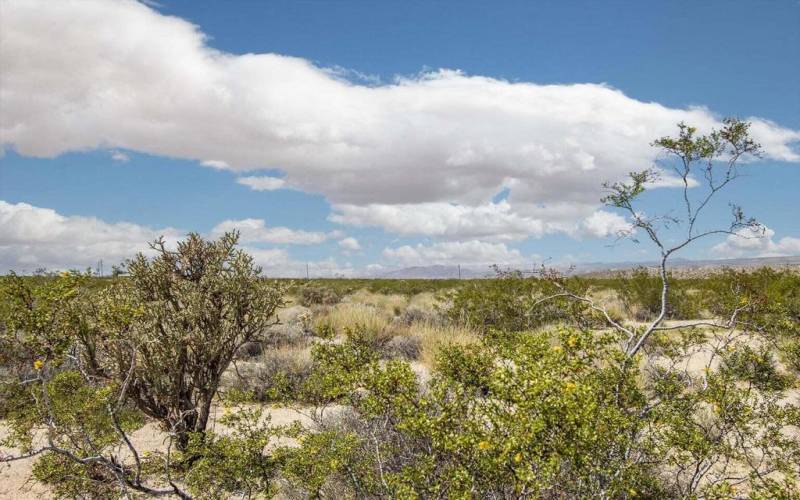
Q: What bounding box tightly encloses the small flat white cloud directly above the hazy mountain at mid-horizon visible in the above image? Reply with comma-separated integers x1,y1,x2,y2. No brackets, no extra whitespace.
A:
383,240,530,266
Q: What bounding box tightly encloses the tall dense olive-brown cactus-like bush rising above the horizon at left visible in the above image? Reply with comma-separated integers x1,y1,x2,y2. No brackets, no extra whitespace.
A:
84,233,282,449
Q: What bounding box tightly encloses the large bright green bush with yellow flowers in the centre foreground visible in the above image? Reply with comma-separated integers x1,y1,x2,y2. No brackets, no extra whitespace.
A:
290,330,659,498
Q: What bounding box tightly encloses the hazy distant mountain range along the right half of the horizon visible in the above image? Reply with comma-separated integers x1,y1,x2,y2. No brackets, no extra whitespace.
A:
372,255,800,279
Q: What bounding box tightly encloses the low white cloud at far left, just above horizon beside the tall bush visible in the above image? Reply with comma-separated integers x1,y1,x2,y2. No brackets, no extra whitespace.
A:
0,201,181,272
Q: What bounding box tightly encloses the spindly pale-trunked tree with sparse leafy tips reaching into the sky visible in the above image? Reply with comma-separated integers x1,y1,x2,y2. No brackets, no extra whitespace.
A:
536,118,764,359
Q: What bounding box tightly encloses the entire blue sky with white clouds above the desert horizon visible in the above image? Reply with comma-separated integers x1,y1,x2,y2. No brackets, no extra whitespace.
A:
0,0,800,277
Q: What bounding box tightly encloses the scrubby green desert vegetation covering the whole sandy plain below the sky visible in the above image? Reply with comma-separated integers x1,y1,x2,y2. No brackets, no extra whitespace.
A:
0,121,800,498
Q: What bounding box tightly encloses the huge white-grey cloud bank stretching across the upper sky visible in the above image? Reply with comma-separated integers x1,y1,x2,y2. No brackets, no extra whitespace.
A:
0,0,800,239
